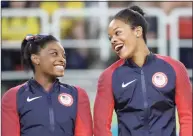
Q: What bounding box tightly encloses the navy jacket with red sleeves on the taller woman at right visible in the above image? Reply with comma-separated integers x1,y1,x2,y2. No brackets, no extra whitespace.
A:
94,53,192,136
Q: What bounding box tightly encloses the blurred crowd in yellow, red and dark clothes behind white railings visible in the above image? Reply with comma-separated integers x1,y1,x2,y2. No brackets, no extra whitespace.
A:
1,1,193,71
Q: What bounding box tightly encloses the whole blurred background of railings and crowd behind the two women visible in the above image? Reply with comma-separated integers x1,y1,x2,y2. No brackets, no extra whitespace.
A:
1,0,193,136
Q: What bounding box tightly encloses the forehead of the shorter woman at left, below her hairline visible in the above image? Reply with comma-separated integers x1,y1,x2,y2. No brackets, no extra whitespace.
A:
45,41,64,51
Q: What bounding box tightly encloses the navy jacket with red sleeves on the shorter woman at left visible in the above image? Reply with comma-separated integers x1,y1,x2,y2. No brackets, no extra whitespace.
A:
2,79,92,136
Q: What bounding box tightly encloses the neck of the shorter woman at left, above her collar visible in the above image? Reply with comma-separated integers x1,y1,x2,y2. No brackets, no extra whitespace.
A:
34,72,56,91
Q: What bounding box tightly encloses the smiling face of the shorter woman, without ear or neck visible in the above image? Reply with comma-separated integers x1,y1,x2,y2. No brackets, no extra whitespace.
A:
34,41,66,77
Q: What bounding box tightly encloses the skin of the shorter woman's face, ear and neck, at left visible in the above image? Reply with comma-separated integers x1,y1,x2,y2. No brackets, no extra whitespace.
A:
31,41,66,91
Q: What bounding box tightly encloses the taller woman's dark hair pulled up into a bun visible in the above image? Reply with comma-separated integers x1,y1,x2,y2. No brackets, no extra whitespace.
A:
113,6,148,43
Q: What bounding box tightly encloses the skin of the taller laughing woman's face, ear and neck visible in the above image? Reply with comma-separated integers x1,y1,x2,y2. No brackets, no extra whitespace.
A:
108,19,150,67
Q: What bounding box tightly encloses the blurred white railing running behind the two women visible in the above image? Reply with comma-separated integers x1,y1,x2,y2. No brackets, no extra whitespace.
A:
2,8,192,90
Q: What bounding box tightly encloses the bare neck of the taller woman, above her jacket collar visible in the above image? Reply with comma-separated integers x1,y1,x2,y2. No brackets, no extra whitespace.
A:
132,42,150,67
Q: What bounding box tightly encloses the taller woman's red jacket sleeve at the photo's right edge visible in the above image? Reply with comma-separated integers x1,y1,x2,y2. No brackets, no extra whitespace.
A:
174,62,193,136
